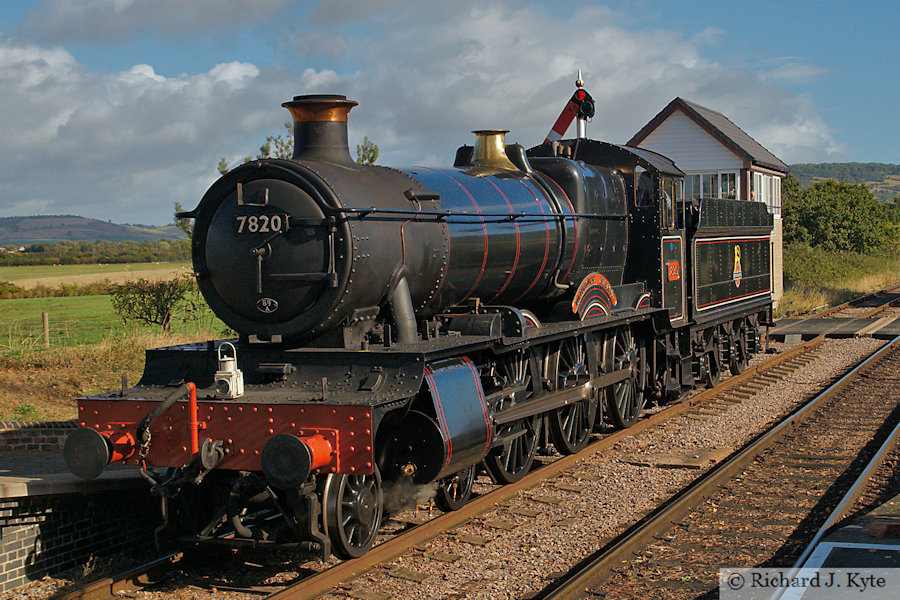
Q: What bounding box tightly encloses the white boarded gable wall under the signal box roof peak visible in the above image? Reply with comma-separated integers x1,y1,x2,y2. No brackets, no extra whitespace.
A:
638,110,744,173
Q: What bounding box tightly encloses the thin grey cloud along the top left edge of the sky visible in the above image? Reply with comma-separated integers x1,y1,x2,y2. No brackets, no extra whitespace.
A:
21,0,291,43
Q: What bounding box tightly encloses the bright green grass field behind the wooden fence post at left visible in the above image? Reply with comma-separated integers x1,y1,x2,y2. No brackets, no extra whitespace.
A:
0,296,225,352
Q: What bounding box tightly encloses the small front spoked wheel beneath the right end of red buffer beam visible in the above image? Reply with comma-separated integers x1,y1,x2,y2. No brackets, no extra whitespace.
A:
323,467,384,559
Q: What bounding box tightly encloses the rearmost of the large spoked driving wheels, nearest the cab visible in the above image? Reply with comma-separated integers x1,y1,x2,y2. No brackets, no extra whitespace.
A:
604,327,647,428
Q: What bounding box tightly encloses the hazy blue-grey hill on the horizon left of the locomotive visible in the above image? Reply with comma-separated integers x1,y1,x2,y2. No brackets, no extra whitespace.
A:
0,215,185,245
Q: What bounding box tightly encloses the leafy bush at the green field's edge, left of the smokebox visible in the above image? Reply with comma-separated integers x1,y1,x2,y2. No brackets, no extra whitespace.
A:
110,275,196,334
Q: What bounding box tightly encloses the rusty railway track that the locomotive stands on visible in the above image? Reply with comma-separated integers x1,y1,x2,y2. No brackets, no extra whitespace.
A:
45,328,876,600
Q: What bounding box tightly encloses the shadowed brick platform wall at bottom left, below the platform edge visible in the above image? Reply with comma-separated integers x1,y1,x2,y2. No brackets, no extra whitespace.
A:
0,481,160,592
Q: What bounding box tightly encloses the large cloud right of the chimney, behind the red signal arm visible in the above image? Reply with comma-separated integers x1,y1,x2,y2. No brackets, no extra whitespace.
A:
297,1,840,164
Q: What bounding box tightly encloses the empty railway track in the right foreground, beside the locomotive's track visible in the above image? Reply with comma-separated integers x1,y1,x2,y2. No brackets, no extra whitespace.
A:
539,338,900,599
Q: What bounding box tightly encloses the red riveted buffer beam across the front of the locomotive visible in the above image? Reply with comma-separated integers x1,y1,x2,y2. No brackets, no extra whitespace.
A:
78,399,374,474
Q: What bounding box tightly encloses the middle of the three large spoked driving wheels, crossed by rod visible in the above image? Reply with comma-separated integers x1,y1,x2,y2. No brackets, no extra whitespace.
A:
547,336,597,454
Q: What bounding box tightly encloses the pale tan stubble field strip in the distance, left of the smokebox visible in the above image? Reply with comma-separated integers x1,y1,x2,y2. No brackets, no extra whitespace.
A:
0,262,191,288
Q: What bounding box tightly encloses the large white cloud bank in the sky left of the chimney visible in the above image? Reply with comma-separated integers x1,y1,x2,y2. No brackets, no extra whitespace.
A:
0,37,315,223
